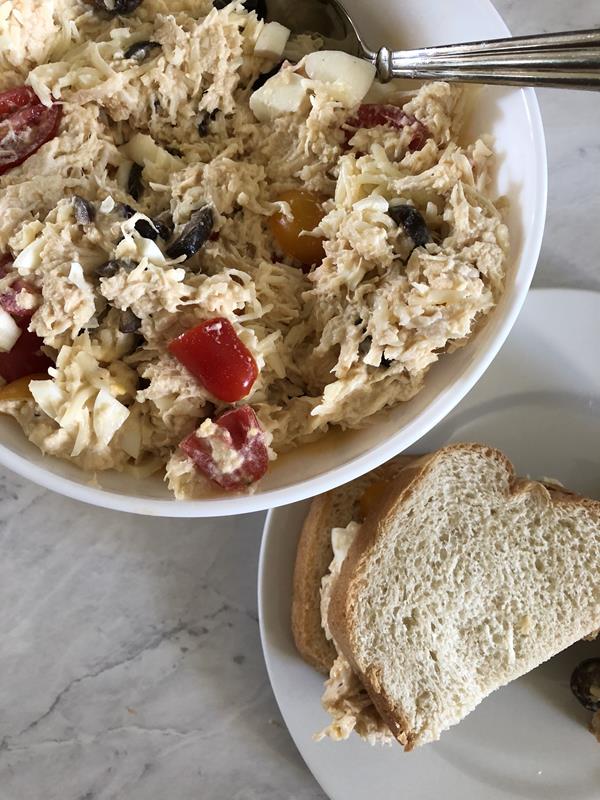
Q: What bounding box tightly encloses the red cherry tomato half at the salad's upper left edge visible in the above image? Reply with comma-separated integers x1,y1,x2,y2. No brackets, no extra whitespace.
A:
0,86,62,175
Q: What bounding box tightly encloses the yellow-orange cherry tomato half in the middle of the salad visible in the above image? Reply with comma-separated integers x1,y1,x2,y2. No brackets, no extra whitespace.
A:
269,189,325,267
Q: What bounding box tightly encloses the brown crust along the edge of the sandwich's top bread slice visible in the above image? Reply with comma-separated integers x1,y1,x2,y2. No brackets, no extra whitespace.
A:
328,444,600,751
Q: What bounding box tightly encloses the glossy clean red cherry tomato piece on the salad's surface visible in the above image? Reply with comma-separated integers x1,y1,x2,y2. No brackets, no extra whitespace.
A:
169,317,258,403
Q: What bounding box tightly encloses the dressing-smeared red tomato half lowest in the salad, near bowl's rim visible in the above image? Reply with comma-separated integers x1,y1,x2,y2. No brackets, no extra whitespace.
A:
179,406,269,491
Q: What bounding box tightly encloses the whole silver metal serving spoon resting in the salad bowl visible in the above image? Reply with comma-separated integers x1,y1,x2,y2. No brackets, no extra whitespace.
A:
266,0,600,91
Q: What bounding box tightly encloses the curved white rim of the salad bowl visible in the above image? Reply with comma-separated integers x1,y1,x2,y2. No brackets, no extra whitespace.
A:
0,9,548,518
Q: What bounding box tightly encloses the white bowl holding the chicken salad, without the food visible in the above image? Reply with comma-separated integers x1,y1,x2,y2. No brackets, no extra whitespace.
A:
0,0,547,517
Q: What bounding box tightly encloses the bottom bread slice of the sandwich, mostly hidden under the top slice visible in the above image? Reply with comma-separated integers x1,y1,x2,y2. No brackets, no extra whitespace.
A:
292,456,413,675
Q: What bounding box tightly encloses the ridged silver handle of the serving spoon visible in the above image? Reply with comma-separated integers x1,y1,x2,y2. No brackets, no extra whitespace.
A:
376,30,600,91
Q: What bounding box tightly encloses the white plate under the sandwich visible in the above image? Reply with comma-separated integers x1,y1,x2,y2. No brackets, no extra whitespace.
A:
258,289,600,800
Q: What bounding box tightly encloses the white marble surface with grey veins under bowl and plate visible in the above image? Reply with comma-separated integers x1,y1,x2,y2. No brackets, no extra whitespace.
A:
0,0,600,800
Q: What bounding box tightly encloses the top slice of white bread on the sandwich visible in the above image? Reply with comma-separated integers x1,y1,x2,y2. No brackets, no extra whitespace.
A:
328,444,600,750
